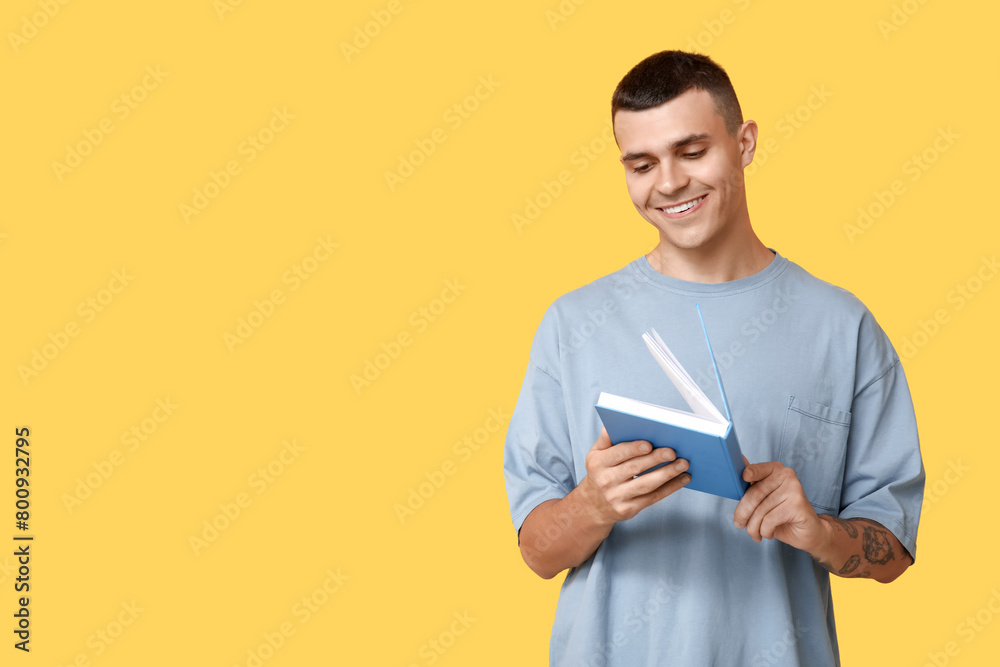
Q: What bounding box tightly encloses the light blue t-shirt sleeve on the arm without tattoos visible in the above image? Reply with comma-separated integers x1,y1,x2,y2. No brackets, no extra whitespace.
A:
504,309,576,532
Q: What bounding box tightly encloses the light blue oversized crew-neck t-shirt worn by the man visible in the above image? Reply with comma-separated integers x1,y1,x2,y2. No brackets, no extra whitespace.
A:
504,255,924,667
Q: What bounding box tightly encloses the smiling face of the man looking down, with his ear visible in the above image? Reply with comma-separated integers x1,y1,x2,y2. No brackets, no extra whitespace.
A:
614,89,757,250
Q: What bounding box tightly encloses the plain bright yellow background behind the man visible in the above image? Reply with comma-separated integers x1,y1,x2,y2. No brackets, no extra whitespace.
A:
0,0,1000,667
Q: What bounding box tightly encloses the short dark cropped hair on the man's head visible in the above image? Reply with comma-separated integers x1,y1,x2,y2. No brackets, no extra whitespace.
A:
611,51,743,136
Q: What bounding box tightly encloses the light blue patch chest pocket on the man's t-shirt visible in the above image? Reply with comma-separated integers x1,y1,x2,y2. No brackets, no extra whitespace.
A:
778,396,851,514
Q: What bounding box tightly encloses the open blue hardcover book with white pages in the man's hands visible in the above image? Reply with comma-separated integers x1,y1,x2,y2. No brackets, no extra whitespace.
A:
595,307,749,500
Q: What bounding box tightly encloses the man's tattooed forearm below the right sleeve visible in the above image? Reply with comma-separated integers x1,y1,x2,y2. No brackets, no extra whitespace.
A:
807,515,913,584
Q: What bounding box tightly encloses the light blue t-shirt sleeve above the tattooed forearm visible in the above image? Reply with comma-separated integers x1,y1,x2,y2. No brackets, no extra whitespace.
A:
840,315,925,558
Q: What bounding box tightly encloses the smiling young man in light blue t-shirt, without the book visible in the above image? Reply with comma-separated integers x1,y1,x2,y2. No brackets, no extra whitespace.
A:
504,51,924,667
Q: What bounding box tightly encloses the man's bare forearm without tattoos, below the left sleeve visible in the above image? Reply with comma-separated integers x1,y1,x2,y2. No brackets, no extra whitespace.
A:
518,477,615,579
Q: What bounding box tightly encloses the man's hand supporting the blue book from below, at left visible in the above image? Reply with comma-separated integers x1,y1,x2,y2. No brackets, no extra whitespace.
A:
580,428,691,525
